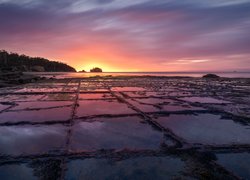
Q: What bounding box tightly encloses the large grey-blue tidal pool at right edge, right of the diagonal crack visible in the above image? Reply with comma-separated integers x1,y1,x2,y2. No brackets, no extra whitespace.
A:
156,114,250,144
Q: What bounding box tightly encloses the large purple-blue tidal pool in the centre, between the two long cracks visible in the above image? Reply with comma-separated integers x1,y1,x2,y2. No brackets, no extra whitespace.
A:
71,116,165,151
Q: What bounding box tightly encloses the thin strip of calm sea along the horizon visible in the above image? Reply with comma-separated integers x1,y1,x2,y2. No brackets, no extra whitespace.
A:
24,72,250,79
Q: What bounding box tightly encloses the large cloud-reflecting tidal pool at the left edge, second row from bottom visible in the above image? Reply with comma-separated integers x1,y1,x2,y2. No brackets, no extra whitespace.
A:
0,125,67,156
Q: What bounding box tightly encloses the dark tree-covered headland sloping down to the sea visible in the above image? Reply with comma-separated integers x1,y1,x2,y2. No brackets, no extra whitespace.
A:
0,50,76,72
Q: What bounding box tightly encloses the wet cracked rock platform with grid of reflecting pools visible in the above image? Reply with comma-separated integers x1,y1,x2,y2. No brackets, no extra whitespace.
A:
0,77,250,179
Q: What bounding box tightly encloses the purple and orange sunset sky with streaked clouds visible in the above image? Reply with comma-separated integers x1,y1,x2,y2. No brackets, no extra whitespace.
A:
0,0,250,72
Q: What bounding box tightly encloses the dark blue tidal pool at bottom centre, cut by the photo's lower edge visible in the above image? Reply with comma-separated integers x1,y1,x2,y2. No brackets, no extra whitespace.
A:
66,157,184,180
